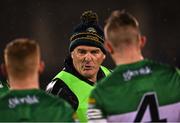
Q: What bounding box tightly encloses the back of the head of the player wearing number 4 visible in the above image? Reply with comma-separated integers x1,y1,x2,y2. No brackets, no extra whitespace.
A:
104,10,145,64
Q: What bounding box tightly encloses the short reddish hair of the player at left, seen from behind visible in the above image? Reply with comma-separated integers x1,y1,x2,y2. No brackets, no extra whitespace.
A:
4,38,40,78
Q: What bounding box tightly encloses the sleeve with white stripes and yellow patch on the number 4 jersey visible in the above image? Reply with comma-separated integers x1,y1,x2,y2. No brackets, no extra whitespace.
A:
87,91,107,123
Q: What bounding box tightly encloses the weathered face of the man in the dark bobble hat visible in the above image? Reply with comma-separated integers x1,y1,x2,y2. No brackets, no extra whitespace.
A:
71,45,105,79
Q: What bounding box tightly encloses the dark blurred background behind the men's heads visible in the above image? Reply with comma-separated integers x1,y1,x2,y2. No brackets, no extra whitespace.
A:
0,0,180,89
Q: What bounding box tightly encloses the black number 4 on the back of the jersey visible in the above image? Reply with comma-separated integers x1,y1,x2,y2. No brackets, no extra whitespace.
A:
134,93,167,122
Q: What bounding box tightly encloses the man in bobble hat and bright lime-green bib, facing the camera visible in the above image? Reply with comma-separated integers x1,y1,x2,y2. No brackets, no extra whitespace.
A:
46,11,110,122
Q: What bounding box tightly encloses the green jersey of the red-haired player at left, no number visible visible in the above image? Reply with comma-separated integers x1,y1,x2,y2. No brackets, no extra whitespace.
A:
0,89,73,122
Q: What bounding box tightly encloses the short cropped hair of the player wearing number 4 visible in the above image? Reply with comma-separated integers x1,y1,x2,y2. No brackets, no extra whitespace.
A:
105,10,140,46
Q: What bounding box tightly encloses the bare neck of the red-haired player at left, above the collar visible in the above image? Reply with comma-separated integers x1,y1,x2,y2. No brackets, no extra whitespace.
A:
9,75,39,90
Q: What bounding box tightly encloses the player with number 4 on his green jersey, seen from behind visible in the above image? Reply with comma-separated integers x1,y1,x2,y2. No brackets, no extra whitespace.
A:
88,11,180,122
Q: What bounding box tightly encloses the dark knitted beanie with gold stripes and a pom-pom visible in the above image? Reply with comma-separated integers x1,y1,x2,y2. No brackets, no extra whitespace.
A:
69,11,106,54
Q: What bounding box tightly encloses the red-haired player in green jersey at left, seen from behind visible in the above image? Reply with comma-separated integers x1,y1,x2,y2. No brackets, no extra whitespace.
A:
0,39,73,122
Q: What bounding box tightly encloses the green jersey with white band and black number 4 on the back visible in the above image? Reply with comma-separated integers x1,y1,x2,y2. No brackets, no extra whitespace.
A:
88,60,180,122
